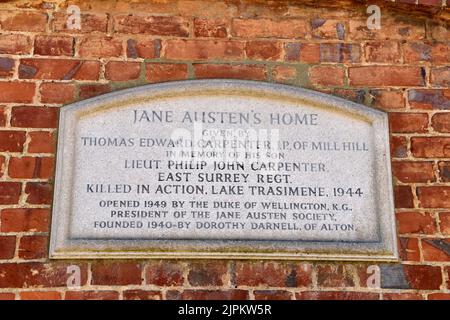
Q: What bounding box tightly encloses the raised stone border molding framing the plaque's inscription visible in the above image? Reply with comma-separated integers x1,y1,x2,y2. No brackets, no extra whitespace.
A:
49,79,399,261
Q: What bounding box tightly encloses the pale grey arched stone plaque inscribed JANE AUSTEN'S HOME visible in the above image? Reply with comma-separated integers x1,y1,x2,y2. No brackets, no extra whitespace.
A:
50,80,397,260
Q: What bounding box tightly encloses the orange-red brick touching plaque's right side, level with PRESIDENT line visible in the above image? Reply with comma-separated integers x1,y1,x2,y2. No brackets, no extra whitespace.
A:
396,212,436,234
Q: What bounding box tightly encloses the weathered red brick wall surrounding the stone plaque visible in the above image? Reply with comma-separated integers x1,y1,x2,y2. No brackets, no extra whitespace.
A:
0,0,450,299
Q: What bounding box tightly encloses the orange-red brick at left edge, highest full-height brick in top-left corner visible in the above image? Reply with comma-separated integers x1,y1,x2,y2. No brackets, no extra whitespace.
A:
0,10,47,32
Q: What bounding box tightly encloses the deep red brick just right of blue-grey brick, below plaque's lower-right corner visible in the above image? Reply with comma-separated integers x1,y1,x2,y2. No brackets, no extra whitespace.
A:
403,265,442,290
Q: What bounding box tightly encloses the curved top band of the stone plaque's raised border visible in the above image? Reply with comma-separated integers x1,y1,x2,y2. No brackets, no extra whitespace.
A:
61,79,387,122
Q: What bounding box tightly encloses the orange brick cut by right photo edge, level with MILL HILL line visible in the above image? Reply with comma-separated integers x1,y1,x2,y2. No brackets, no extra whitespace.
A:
411,137,450,158
